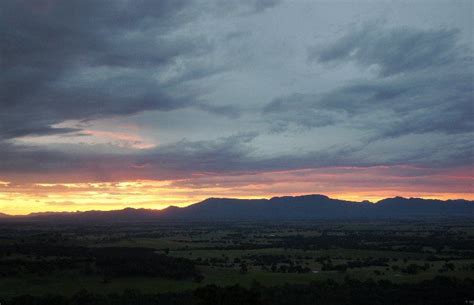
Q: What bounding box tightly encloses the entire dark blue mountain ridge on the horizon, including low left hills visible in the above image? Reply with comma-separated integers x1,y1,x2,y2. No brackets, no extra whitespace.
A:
0,195,474,222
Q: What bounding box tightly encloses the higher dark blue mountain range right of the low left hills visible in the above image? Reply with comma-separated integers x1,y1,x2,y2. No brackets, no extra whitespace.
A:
160,195,474,220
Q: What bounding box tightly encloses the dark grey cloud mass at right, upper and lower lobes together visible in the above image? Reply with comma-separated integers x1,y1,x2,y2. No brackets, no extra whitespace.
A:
264,26,474,139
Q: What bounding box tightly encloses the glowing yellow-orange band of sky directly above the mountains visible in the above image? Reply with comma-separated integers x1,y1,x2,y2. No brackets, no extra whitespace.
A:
0,166,474,215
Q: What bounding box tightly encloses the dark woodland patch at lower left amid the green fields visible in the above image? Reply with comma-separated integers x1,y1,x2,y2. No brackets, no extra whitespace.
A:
0,244,202,281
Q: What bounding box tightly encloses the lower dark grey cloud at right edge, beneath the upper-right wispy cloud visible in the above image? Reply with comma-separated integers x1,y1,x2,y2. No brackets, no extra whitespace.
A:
332,65,474,137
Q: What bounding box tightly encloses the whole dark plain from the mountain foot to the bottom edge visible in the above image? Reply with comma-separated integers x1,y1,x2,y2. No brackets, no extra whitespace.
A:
0,218,474,305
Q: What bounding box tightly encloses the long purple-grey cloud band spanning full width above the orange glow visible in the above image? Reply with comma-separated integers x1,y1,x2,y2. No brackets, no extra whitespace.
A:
0,124,474,182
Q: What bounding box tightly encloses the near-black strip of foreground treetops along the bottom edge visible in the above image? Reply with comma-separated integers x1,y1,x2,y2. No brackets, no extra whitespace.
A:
0,277,474,305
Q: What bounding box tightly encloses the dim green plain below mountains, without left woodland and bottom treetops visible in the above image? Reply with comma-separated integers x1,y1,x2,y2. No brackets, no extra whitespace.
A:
0,218,474,297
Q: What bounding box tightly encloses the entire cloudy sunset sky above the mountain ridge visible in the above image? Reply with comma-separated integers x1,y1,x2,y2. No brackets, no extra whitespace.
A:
0,0,474,214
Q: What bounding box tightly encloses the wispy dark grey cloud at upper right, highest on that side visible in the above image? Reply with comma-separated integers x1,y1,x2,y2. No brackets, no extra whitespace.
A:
308,24,459,76
